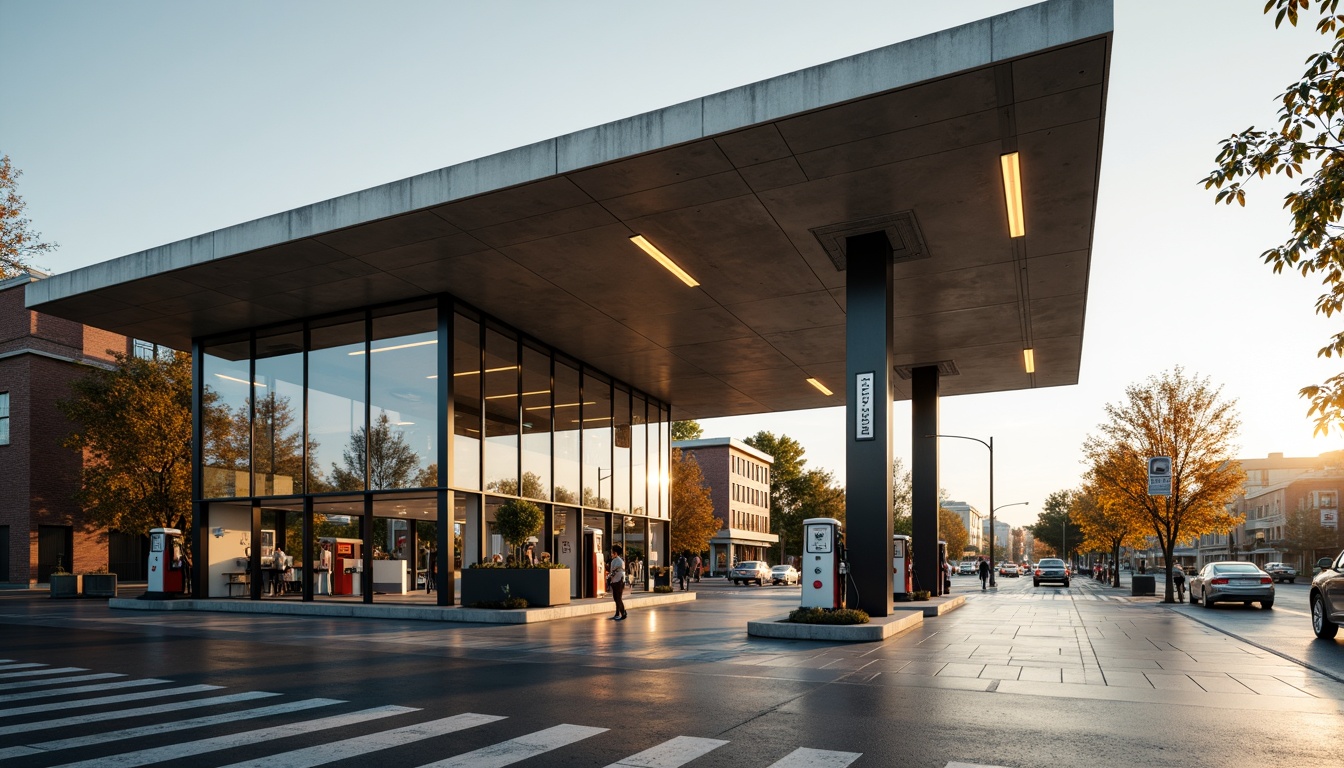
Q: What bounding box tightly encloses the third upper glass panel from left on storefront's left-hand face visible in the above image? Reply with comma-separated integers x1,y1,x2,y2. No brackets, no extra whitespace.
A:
308,316,367,494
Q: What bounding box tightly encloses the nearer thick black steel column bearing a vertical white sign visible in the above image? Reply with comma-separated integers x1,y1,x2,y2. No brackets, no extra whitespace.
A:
844,231,892,616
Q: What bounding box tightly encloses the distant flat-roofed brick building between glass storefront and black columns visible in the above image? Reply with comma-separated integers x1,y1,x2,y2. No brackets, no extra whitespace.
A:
672,437,780,576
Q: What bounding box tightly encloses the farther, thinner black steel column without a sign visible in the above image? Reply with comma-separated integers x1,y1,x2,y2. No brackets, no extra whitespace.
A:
910,366,940,594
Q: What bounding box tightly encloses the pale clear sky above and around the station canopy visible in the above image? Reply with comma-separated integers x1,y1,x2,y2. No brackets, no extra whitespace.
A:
0,0,1341,525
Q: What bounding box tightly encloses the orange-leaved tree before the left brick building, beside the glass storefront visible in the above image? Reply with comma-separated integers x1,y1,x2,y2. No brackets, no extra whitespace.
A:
58,352,191,534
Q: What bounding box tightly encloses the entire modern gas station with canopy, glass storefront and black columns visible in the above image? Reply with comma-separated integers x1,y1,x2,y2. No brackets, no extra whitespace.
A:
27,0,1113,616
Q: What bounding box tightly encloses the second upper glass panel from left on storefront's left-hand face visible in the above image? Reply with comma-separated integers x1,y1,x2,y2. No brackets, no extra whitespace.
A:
253,328,305,494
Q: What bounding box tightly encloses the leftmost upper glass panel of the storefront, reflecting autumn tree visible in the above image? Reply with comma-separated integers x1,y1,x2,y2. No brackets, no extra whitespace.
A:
200,338,251,499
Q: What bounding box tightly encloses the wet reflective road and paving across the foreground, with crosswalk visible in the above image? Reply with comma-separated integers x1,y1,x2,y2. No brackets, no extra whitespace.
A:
0,578,1344,768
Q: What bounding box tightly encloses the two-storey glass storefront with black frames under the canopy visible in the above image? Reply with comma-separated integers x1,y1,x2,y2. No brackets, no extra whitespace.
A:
194,296,671,605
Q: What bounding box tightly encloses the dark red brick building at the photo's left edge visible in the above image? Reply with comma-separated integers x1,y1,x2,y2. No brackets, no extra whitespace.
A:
0,272,133,586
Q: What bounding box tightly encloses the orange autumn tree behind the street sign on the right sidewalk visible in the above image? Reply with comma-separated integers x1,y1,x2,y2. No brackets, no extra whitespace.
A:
1083,366,1246,603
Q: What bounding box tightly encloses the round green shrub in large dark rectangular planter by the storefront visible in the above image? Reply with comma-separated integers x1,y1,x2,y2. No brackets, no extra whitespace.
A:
462,499,570,605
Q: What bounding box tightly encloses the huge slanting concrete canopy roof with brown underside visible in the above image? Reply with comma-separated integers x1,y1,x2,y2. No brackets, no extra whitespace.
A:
28,0,1111,418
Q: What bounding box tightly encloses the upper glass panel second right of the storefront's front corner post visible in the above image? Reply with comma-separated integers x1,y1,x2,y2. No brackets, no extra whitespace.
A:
484,328,519,496
